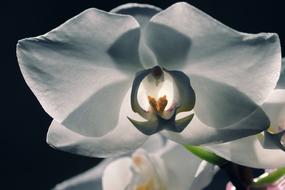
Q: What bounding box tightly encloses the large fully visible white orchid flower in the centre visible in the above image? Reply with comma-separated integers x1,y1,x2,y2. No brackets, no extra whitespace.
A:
17,2,281,157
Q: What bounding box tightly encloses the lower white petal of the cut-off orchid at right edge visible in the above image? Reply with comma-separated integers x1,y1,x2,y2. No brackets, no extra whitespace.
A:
205,136,285,169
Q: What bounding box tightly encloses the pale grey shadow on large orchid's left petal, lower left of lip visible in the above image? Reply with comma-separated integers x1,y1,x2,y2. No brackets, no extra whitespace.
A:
62,81,130,137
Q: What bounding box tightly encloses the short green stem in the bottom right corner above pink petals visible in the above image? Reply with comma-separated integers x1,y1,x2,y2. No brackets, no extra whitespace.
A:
252,167,285,186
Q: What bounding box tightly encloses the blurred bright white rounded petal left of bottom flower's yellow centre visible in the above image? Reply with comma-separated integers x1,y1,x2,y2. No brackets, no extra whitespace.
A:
102,157,133,190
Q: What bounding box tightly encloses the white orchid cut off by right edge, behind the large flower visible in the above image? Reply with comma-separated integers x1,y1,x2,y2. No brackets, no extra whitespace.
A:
206,58,285,168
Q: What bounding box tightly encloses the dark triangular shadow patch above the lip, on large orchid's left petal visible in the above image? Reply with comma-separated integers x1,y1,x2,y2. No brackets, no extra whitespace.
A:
108,28,143,73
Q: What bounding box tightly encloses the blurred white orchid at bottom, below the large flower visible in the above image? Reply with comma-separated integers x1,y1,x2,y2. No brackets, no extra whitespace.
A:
54,135,217,190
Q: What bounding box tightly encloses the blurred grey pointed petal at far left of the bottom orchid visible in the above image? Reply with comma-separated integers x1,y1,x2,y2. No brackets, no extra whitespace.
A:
53,159,113,190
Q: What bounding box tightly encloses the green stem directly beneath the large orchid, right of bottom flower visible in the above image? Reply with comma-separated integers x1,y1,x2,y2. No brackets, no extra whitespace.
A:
184,145,228,166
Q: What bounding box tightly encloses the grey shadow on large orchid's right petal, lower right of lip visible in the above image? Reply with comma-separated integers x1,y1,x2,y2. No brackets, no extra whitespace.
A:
190,75,260,129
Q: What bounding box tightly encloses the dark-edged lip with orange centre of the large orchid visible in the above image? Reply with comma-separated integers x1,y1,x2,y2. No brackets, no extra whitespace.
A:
128,66,195,135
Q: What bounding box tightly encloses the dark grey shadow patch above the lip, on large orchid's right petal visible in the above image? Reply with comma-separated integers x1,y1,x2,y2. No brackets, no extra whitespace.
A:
142,22,191,69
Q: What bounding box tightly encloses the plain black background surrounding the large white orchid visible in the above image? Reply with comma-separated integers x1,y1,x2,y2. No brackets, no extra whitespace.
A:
0,0,285,190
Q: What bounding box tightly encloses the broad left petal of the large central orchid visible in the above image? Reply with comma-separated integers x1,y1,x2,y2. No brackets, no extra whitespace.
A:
17,9,142,136
